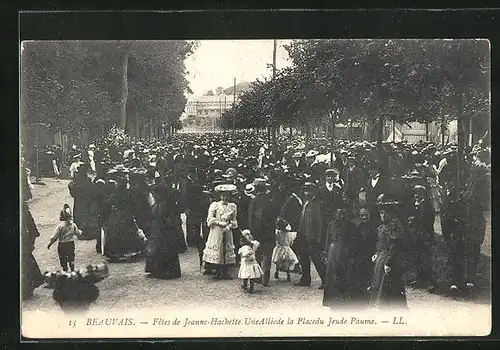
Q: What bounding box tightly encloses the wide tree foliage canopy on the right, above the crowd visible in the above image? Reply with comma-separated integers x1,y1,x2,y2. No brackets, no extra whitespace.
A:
224,39,490,133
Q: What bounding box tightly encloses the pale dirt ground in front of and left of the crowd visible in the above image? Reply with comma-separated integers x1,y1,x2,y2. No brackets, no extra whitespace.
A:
23,179,490,311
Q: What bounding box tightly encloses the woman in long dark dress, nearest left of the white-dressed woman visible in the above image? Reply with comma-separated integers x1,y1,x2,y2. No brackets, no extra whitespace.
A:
146,185,181,279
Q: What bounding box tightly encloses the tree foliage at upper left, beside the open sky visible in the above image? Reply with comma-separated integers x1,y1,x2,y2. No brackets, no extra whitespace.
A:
21,41,196,137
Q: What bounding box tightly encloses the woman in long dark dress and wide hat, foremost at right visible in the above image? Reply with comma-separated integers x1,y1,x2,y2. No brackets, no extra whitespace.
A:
370,200,407,308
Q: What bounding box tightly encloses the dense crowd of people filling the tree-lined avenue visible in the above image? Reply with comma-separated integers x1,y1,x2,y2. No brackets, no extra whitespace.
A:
23,132,490,307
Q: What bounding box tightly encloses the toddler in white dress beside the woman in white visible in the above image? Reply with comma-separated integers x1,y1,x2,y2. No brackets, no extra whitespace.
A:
238,230,264,294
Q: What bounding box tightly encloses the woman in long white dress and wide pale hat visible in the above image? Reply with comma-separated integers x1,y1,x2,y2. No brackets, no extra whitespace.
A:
203,185,238,279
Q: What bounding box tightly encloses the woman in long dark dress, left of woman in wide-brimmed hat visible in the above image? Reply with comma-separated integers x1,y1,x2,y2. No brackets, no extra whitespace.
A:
323,206,358,307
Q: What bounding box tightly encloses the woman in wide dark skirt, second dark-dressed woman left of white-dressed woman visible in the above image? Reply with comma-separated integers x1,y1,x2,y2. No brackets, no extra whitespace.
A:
104,171,145,262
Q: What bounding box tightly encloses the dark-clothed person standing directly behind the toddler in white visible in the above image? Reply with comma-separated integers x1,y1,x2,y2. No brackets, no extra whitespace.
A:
248,179,277,286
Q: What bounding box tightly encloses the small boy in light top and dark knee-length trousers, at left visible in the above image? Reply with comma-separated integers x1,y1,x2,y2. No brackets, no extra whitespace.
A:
47,204,82,271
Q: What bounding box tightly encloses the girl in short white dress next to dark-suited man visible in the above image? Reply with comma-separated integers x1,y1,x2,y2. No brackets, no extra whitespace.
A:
272,218,299,282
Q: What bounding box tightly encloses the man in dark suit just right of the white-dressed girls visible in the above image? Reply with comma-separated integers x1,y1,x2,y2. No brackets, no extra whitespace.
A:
296,182,326,289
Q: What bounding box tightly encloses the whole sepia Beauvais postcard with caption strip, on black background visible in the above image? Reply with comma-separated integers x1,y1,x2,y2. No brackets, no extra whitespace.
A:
19,37,492,339
